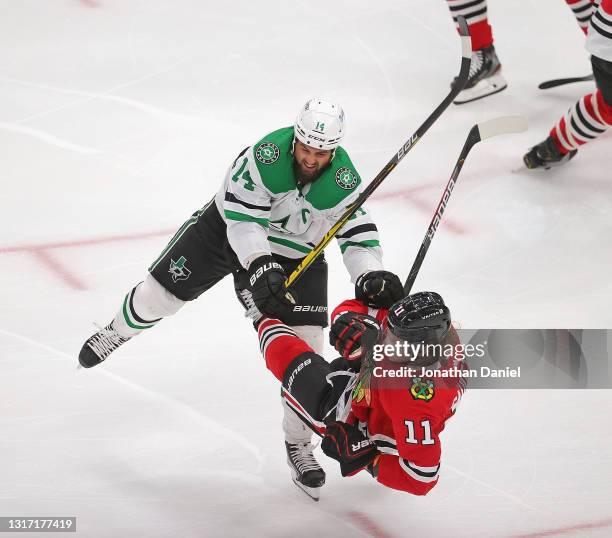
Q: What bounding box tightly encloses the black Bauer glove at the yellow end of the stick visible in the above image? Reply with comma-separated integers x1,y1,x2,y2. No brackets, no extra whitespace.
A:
248,255,297,319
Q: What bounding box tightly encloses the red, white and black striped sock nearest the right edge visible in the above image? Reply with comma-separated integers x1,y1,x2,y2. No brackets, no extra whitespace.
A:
550,90,612,155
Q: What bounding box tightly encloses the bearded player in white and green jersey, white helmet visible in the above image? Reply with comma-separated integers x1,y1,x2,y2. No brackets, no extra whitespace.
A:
79,99,402,494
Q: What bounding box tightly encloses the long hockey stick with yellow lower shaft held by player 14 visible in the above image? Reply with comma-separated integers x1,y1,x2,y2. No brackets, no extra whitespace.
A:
285,17,472,288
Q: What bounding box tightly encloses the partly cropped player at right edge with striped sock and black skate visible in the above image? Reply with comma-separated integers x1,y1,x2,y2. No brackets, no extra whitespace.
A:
523,0,612,169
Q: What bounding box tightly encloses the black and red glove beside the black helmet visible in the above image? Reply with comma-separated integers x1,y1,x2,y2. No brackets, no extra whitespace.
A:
329,312,380,361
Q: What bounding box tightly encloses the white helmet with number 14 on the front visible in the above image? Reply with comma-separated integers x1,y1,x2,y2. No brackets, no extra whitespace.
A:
294,98,344,150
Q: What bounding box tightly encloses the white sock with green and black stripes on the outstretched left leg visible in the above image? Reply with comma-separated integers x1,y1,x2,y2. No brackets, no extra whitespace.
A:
113,275,185,338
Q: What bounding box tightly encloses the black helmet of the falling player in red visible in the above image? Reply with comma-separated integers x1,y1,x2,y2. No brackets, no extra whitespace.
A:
387,291,451,344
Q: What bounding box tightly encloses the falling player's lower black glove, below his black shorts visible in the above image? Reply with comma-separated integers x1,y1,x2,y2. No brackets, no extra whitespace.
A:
321,421,379,476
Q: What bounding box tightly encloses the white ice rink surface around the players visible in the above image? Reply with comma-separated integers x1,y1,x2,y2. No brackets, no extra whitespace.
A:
0,0,612,538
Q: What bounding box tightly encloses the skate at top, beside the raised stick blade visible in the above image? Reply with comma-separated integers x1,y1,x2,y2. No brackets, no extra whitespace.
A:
453,45,508,105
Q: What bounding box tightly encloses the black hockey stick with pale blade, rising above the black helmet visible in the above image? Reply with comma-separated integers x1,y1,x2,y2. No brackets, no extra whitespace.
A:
404,116,527,295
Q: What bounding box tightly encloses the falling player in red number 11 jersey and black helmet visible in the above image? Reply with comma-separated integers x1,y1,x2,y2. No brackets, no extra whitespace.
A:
258,286,465,500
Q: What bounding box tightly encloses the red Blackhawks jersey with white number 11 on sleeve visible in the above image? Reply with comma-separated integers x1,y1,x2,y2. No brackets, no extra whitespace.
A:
332,300,465,495
